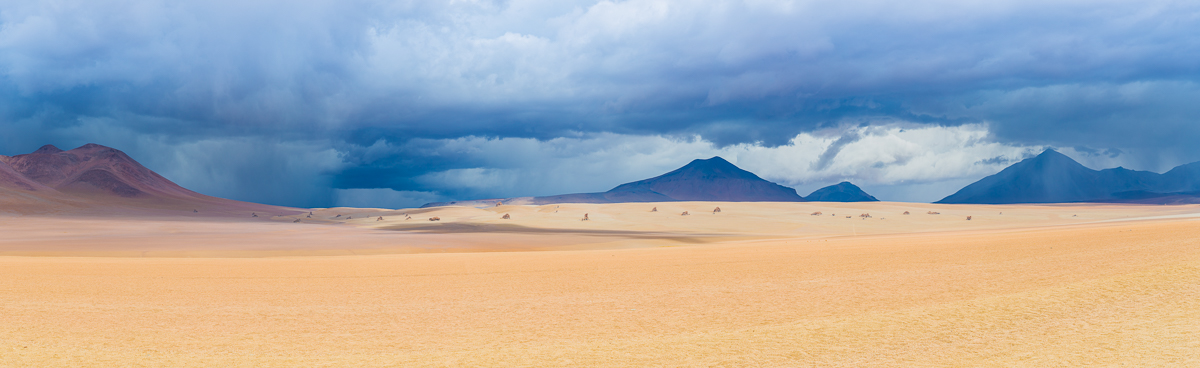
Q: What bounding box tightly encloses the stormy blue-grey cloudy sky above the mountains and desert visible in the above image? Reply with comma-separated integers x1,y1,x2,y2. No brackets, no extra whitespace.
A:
0,0,1200,207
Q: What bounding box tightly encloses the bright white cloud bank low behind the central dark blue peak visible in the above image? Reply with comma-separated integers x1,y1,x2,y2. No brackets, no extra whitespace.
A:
398,122,1044,200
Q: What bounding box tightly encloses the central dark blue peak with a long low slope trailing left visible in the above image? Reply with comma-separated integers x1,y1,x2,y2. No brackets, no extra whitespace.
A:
424,157,804,207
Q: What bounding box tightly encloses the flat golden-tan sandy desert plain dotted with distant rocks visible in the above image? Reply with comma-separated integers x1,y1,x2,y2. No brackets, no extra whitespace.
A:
0,203,1200,367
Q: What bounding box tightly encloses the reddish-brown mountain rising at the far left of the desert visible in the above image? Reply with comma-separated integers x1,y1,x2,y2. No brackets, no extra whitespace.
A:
0,144,298,213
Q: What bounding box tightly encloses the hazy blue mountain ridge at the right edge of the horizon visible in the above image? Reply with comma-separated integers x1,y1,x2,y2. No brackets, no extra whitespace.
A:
937,150,1200,204
